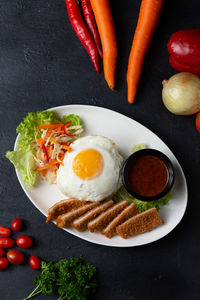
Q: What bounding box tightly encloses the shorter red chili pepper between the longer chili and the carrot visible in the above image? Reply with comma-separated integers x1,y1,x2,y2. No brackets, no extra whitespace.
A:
81,0,103,58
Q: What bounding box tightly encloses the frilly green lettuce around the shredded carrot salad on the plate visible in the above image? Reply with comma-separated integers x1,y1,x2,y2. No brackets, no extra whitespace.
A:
6,110,83,188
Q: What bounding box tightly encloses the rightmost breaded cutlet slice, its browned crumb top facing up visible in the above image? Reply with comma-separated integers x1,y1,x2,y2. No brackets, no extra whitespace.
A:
116,207,162,239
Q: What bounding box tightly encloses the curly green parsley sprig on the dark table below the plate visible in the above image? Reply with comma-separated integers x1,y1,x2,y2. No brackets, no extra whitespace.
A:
24,257,97,300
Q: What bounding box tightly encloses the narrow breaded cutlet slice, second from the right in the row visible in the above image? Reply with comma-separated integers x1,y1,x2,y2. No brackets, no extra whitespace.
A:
102,203,138,238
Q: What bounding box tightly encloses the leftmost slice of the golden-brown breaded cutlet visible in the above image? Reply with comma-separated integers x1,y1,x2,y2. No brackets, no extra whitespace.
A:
46,198,87,223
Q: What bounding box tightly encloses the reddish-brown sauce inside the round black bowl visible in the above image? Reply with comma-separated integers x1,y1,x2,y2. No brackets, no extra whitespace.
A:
128,155,169,197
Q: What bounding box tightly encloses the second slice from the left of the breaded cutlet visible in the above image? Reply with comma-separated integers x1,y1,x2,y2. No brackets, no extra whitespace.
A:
56,202,99,228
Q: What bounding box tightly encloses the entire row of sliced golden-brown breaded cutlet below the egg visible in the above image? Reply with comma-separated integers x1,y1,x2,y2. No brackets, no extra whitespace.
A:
47,198,162,239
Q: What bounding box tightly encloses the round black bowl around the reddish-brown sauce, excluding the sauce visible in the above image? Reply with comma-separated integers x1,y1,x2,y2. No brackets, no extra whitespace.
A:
122,149,175,201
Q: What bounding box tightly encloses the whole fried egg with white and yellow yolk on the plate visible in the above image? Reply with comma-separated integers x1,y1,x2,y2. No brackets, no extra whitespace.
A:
57,135,123,201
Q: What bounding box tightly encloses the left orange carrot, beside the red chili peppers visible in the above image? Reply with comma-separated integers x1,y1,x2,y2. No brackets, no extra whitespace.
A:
90,0,117,89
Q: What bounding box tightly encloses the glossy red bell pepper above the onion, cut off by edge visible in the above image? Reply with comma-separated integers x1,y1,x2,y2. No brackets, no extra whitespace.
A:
167,29,200,75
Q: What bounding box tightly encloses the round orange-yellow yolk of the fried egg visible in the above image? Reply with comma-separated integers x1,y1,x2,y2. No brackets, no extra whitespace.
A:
72,149,103,180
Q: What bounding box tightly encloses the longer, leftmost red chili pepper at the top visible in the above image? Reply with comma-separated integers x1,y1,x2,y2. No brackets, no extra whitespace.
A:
65,0,100,73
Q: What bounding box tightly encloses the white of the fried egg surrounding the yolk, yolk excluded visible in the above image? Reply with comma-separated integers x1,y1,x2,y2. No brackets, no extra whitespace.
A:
57,135,123,201
